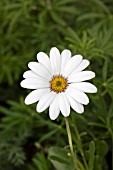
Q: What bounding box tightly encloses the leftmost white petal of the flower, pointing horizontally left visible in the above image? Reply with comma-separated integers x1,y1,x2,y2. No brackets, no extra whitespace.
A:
20,78,50,89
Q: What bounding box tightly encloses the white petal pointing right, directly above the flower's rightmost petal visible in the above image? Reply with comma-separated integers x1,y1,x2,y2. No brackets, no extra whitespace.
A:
68,71,95,83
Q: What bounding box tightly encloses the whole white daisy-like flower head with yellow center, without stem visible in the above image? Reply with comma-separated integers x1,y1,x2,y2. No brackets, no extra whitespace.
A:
21,47,97,120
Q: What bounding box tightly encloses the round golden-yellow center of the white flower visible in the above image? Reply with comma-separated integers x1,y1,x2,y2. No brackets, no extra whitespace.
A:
50,76,68,93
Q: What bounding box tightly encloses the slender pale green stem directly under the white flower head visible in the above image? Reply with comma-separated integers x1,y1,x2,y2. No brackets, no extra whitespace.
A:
65,118,79,170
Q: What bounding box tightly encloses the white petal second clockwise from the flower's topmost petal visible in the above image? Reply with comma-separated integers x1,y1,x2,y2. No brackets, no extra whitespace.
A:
63,55,83,77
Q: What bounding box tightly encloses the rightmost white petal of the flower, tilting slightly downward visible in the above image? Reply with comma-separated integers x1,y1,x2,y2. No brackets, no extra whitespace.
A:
69,82,97,93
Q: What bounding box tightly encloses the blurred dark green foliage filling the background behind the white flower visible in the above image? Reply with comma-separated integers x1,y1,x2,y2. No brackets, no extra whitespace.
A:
0,0,113,170
